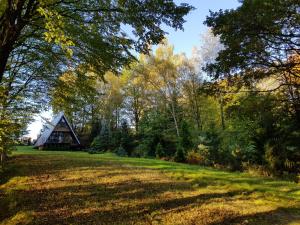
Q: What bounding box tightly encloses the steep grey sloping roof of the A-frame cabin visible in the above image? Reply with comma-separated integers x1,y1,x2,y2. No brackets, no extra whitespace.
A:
34,112,80,147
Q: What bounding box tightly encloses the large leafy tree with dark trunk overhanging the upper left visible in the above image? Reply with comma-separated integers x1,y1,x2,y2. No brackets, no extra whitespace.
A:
0,0,192,156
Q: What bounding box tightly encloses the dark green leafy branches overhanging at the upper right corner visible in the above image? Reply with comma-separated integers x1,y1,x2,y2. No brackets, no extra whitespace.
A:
205,0,300,124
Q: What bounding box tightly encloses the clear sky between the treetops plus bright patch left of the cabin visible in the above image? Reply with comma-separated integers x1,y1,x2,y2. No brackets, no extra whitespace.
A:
28,0,239,139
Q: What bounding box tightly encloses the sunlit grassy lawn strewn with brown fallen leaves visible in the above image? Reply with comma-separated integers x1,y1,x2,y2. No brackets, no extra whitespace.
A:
0,147,300,225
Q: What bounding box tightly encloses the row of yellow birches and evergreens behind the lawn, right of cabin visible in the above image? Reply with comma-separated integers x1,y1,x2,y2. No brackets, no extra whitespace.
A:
51,31,299,178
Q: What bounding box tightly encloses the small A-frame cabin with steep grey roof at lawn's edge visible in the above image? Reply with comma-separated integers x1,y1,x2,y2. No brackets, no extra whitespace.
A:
34,112,80,149
